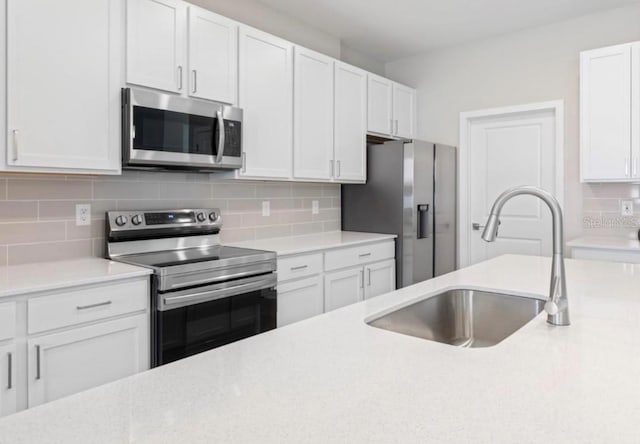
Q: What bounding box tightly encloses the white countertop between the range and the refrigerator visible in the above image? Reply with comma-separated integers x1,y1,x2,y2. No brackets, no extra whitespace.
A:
225,231,396,256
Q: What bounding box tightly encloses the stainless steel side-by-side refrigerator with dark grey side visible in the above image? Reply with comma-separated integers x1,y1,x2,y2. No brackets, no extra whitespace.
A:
342,140,456,288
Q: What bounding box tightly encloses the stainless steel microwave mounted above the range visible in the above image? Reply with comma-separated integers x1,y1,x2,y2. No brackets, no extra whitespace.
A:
122,88,242,170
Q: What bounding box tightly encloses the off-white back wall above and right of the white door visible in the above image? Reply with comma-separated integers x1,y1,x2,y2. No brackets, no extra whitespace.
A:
386,5,640,239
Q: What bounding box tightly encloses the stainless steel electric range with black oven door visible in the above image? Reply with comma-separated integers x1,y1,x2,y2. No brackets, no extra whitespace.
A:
106,208,277,367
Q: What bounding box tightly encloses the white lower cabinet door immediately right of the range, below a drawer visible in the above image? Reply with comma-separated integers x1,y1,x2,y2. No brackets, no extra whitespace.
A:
278,276,324,327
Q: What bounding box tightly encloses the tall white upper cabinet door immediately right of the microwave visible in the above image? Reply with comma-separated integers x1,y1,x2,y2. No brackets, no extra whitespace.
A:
239,26,293,178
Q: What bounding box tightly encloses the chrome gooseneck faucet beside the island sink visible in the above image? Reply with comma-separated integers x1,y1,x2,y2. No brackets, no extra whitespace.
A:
482,186,569,325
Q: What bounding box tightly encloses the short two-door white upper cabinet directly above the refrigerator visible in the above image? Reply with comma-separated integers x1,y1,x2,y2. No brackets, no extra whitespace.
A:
367,74,416,139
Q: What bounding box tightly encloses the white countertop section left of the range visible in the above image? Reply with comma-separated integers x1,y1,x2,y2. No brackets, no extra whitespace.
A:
0,257,151,297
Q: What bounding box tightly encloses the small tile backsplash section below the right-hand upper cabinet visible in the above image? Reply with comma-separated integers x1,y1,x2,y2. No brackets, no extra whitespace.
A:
582,183,640,239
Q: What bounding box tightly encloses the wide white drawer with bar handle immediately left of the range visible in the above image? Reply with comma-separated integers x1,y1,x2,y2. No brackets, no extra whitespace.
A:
27,279,150,334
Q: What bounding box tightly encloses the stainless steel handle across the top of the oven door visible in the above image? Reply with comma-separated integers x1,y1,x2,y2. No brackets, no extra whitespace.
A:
159,273,277,311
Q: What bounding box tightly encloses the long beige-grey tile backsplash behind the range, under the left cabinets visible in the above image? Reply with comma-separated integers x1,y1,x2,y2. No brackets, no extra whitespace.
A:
0,171,340,265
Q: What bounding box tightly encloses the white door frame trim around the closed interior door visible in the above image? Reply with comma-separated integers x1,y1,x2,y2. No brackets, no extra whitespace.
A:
457,100,564,268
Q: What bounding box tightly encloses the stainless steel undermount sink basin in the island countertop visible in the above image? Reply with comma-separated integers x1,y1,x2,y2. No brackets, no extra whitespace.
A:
367,289,545,348
